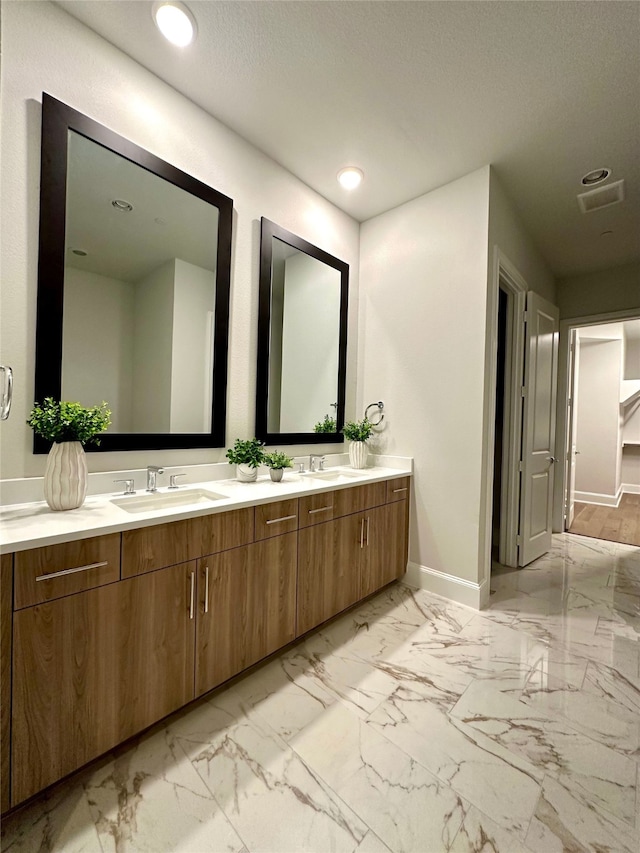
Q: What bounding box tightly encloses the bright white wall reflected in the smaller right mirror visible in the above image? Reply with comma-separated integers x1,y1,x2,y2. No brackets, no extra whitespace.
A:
280,252,341,432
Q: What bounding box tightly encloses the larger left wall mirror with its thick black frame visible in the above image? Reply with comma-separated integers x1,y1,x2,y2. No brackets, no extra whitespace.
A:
34,93,233,453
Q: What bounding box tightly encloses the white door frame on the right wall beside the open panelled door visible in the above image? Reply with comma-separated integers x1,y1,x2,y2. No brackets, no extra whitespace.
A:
479,246,528,592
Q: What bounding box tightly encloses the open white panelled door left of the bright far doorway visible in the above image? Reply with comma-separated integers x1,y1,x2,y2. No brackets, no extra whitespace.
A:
518,291,559,566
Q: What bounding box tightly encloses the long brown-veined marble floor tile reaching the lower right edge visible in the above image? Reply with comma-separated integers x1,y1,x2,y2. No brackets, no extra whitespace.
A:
451,681,637,825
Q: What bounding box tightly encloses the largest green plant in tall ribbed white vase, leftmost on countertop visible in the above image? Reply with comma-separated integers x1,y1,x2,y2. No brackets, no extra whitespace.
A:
27,397,111,511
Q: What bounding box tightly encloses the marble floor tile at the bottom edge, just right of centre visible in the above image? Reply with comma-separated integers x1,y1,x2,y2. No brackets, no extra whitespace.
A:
292,704,467,851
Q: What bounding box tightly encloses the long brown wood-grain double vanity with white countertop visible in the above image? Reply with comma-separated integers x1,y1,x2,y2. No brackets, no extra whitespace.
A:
1,468,410,812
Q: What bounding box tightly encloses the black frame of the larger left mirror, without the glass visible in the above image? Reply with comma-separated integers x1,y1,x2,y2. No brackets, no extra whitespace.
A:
33,92,233,453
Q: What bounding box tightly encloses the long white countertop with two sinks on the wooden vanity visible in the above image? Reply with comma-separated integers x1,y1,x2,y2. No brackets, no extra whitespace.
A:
0,457,412,554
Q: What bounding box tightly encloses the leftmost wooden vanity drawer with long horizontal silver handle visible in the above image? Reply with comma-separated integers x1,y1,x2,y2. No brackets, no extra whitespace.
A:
14,533,120,610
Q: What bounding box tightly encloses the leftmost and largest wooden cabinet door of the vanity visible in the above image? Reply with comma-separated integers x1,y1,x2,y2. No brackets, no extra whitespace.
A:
11,563,195,805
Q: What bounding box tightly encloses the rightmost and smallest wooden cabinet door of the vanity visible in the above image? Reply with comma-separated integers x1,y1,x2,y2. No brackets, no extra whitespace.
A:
360,500,407,598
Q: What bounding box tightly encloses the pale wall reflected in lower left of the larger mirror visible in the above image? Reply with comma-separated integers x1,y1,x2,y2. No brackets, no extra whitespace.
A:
61,267,134,430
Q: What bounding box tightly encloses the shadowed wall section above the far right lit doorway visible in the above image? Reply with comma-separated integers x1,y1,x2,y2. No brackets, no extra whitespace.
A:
557,263,640,319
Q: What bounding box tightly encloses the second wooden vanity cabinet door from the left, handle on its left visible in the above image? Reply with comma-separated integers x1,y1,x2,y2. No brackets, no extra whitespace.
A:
196,533,297,696
